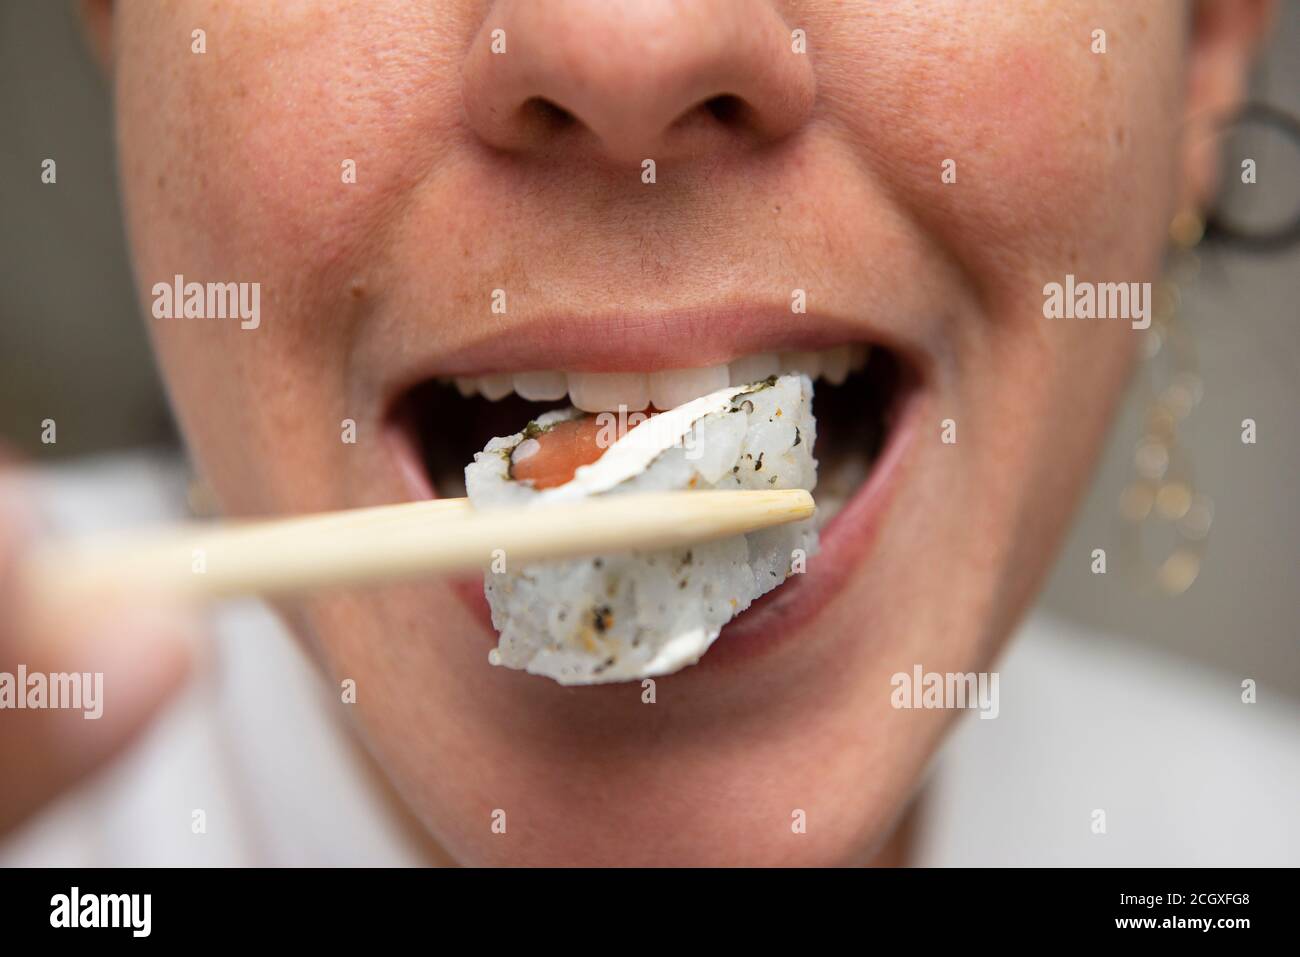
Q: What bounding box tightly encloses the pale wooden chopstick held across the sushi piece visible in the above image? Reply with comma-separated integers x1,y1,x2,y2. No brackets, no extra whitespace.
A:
23,489,815,601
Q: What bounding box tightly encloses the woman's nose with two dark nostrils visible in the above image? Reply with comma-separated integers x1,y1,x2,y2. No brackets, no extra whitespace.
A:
462,0,815,164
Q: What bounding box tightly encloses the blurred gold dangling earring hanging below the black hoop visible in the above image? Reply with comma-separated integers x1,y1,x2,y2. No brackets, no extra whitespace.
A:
1119,211,1214,596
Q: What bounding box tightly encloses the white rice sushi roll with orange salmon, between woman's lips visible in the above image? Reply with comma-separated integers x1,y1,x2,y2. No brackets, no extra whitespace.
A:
465,374,816,685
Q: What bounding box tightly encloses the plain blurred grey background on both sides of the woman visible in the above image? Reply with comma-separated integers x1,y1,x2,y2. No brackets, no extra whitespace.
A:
0,0,1300,698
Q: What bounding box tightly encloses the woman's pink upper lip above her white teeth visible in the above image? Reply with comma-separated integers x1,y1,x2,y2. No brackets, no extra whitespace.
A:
386,303,927,402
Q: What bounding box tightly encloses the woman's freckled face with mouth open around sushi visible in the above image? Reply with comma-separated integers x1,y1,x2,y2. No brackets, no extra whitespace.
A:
92,0,1263,863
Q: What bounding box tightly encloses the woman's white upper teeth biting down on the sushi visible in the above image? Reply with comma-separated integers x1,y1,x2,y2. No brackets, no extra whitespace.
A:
455,345,868,412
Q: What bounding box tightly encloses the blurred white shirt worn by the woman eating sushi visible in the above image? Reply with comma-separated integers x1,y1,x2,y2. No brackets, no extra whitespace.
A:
0,454,1300,866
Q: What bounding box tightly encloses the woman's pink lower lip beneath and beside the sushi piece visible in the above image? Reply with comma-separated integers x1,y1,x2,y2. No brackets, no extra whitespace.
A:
450,390,922,668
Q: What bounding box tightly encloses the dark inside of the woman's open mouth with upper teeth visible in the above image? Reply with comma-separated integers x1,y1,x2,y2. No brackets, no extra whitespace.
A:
394,343,913,527
